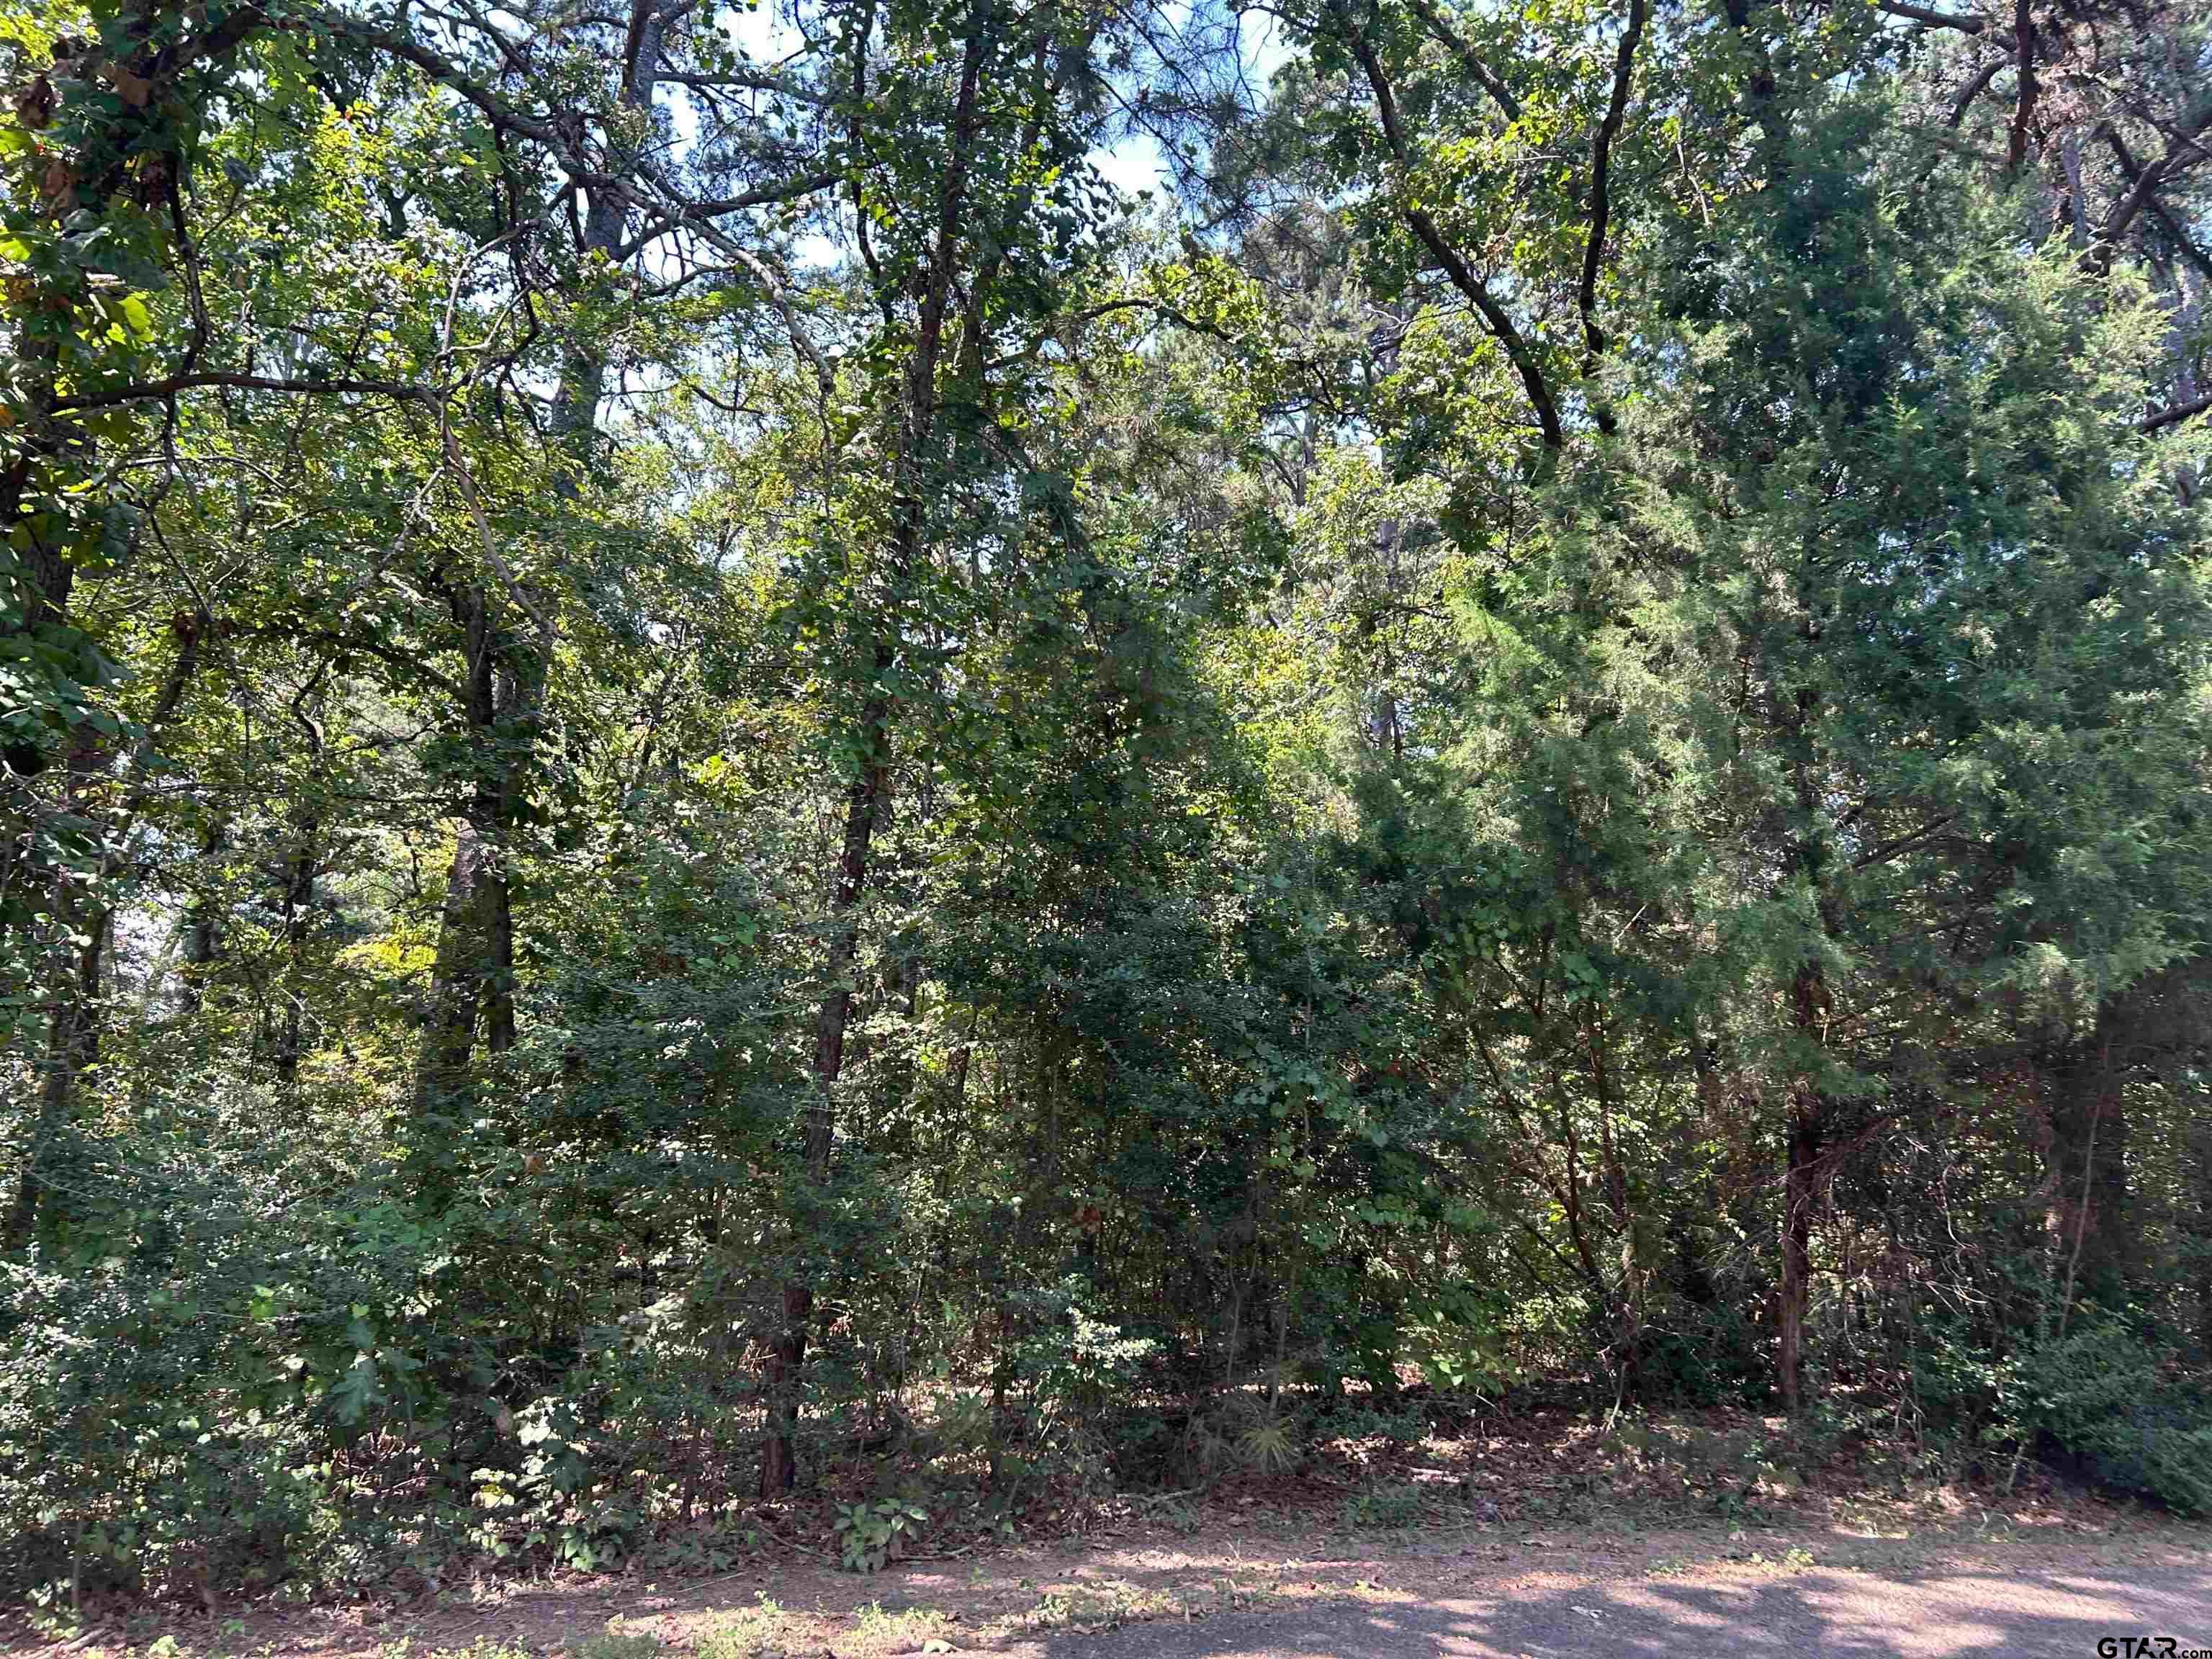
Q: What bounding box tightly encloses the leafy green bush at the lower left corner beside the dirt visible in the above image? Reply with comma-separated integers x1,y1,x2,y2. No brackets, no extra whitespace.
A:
0,1092,451,1604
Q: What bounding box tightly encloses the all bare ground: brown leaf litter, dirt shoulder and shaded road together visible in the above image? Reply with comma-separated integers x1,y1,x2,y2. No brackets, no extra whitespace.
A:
17,1413,2212,1659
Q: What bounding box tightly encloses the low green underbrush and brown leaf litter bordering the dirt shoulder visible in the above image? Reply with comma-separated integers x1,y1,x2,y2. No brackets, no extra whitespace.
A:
13,1254,2212,1608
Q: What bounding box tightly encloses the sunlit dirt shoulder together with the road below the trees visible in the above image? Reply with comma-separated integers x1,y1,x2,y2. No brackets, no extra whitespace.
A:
21,1511,2212,1659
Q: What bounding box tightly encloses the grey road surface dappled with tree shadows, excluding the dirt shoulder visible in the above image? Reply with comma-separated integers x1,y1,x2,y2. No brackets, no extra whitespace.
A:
1015,1557,2212,1659
